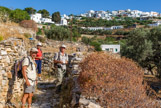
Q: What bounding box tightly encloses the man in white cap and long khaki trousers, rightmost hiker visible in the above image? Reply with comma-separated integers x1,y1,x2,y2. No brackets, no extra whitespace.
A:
54,45,68,92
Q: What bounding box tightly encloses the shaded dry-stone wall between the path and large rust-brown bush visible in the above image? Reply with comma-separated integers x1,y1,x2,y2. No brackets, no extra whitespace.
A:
58,52,101,108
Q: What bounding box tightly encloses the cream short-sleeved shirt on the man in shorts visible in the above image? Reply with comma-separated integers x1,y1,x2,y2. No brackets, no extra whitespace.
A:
22,56,37,85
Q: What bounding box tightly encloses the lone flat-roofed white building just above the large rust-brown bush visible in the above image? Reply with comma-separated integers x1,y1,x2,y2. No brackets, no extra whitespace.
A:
101,44,120,53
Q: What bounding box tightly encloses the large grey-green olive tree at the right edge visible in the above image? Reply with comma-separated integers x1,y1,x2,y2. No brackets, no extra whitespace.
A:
121,27,161,77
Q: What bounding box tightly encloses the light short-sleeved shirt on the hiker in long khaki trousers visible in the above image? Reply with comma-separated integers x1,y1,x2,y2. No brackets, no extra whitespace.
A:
54,52,68,70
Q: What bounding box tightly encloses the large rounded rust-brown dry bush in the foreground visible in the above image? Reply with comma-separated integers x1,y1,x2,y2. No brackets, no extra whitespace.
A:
78,52,158,108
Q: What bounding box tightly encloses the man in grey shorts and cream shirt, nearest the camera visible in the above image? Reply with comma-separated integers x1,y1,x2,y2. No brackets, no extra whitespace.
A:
22,48,38,108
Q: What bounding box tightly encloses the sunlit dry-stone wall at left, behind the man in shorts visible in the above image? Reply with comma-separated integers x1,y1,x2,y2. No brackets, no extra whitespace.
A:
0,38,27,108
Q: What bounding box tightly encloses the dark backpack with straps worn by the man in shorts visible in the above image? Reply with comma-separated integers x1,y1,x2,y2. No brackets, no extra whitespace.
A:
15,57,33,79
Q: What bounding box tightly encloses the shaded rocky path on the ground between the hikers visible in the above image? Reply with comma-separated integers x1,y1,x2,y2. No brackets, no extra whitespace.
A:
32,79,59,108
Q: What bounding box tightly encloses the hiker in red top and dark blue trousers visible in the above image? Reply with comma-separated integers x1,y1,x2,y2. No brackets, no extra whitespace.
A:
35,43,43,81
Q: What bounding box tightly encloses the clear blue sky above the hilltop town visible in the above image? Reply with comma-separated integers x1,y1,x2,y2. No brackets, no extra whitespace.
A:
0,0,161,15
